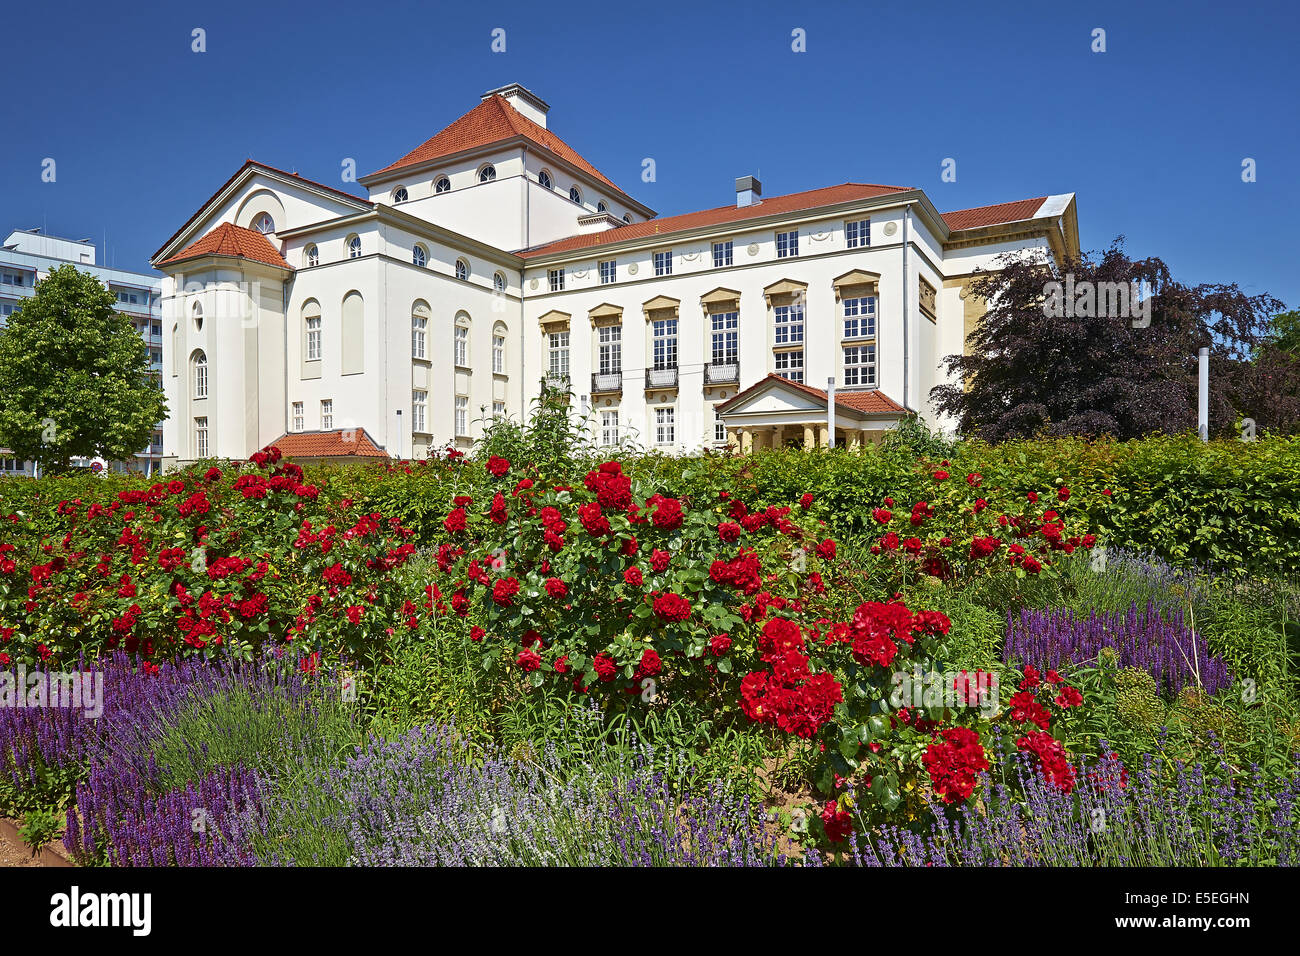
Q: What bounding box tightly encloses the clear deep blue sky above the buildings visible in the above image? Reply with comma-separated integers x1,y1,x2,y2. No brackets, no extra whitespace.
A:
0,0,1300,307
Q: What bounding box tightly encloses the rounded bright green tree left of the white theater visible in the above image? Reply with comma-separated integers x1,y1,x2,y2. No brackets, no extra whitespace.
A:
0,265,166,471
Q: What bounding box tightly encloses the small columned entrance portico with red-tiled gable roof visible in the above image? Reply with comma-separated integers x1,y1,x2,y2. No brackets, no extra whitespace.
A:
718,375,907,454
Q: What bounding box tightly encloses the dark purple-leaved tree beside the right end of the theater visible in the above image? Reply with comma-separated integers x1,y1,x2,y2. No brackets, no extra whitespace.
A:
931,238,1284,441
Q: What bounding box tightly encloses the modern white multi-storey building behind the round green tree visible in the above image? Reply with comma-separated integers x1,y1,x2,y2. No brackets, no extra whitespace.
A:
0,229,163,476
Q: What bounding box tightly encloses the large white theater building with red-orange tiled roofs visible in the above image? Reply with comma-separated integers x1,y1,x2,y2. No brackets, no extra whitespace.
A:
153,85,1079,463
